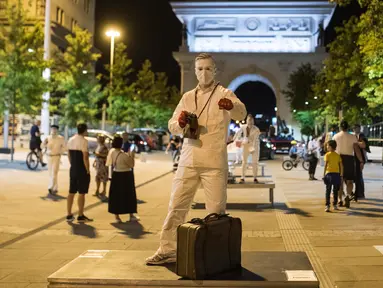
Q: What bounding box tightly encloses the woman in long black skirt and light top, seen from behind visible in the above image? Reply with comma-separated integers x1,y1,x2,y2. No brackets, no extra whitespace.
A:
106,136,139,223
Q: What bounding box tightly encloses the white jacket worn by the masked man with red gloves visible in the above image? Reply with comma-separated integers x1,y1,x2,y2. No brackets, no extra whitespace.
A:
169,85,247,169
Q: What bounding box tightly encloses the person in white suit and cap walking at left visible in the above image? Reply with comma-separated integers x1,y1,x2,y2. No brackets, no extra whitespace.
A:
44,125,65,195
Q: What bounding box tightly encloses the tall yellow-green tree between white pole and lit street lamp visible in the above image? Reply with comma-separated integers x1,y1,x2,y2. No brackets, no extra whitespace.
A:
53,27,102,127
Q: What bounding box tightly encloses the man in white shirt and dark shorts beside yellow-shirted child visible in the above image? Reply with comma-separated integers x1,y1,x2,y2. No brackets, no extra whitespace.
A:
333,120,364,208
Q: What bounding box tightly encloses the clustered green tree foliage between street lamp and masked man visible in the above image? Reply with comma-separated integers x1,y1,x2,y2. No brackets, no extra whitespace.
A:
105,47,179,127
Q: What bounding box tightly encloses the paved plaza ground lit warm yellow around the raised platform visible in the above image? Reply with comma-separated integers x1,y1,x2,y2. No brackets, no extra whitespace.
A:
0,151,383,288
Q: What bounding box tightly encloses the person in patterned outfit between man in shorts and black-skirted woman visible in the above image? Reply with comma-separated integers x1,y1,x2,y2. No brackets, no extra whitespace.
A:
93,134,109,200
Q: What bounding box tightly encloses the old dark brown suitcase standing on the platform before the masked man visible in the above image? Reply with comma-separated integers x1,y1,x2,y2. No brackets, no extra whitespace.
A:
176,213,242,280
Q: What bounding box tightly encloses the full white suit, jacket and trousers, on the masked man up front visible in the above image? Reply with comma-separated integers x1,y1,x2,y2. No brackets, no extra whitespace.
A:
157,85,246,254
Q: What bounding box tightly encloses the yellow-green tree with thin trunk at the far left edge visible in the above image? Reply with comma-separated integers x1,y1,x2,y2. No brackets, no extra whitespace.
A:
0,0,50,160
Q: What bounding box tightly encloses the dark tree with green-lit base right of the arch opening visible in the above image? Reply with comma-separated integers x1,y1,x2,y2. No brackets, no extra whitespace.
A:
282,63,320,136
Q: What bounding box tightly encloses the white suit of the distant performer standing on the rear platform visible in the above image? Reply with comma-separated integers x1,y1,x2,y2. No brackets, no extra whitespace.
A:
236,124,261,179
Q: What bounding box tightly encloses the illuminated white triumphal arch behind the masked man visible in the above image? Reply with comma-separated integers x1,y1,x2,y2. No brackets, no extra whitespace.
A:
171,0,335,137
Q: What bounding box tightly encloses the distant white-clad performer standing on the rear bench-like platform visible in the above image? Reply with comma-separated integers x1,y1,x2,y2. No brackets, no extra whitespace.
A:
237,114,261,183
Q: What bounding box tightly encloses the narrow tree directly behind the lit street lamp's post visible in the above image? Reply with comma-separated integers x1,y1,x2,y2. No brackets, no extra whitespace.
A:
104,43,135,125
